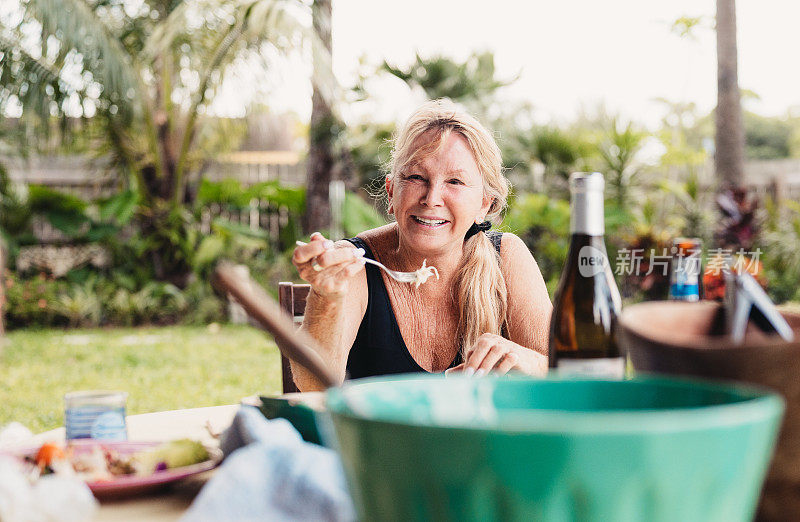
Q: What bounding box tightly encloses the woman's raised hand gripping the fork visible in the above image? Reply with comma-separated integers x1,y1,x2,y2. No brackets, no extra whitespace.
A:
292,232,364,298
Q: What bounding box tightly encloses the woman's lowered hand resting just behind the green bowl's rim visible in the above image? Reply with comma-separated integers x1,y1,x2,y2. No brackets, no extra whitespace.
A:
445,333,547,377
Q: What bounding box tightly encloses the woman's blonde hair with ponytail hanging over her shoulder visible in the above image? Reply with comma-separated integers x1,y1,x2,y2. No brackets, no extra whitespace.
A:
388,100,511,355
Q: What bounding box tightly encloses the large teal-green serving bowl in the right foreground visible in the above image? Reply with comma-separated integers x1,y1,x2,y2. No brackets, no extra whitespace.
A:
327,376,783,522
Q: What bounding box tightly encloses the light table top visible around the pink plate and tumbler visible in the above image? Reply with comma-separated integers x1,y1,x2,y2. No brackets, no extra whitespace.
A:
31,404,239,522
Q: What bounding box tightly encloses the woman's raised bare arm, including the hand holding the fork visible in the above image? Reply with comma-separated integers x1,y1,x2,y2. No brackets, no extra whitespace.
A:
291,233,368,391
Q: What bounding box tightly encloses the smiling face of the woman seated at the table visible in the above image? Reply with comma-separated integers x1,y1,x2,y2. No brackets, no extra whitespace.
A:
386,132,492,253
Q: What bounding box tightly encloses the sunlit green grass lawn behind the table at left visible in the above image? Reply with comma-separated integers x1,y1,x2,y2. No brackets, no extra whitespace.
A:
0,325,281,432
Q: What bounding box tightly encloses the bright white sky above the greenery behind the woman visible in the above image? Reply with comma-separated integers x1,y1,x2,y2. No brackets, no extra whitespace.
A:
248,0,800,125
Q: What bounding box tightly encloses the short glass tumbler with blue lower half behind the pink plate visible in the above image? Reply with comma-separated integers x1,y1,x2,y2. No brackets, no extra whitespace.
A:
64,391,128,440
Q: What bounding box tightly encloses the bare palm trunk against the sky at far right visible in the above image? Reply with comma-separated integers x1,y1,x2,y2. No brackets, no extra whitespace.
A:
714,0,744,188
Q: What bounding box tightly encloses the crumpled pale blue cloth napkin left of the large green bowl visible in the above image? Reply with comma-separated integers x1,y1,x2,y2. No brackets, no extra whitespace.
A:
181,406,356,522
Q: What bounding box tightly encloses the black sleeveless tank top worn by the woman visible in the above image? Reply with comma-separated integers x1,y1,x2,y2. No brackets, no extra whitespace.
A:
347,231,503,379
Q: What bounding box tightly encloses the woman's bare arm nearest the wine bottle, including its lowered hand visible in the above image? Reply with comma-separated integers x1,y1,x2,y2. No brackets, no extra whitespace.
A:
448,233,553,376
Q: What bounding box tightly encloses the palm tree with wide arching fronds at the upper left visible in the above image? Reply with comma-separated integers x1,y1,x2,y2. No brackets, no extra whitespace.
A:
0,0,333,283
